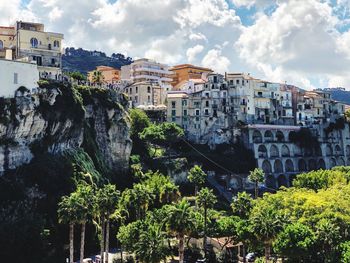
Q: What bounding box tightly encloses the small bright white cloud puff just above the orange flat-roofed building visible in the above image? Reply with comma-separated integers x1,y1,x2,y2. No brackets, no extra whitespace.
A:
202,49,231,74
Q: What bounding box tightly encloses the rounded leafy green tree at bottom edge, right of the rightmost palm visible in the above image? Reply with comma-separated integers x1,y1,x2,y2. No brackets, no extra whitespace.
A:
273,222,316,262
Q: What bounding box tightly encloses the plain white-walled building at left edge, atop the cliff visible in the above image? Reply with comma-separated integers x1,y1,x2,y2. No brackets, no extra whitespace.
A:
0,59,39,98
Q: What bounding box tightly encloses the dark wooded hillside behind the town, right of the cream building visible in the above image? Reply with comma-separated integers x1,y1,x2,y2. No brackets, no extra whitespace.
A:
62,47,132,74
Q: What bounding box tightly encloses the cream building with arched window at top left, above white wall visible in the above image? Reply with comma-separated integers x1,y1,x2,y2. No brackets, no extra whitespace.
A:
0,21,63,79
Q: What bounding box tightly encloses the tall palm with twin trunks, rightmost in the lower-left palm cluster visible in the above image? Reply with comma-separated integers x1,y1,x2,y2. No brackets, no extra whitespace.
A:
96,184,120,262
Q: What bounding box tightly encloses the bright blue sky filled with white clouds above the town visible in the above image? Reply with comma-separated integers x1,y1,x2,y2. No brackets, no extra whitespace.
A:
0,0,350,90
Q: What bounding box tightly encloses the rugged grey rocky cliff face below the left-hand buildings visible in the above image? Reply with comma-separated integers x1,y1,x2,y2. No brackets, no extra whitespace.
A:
0,82,132,174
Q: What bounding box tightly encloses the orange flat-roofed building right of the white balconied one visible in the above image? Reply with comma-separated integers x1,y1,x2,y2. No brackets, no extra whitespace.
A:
169,64,213,89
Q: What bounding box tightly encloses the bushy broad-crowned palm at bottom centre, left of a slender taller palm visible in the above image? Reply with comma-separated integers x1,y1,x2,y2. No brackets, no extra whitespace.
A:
166,199,194,263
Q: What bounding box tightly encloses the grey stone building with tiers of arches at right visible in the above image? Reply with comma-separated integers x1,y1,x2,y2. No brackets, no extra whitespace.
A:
243,121,350,188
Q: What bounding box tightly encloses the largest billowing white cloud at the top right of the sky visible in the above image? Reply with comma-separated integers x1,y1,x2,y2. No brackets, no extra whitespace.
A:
236,0,350,87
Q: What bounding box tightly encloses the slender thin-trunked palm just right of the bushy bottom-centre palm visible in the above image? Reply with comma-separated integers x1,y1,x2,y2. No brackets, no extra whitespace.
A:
196,188,217,260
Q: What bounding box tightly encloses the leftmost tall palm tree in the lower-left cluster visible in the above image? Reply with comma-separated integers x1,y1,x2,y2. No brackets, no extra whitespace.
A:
58,193,79,263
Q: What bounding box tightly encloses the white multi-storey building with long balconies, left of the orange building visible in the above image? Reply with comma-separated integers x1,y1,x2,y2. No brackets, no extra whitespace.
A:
121,58,172,90
